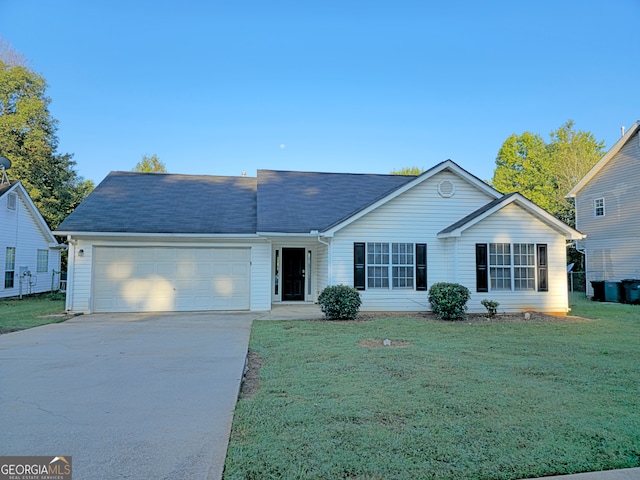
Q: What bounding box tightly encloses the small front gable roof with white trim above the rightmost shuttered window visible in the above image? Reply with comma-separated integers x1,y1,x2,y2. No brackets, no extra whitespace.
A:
437,192,585,240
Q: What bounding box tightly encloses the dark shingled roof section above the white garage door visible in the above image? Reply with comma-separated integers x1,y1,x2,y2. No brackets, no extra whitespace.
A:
57,172,256,234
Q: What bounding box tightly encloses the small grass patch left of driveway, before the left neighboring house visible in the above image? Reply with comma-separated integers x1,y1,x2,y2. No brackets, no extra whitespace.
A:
0,294,68,333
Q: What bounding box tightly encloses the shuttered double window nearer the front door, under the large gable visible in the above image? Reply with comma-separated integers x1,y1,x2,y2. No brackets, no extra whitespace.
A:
353,242,427,290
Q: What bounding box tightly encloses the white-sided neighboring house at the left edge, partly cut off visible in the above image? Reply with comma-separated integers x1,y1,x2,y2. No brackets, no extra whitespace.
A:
0,180,65,298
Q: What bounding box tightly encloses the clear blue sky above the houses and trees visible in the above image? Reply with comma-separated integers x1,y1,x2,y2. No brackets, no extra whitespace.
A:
0,0,640,184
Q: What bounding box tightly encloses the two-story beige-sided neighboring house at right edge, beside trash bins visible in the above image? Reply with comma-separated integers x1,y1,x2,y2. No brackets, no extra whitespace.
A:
567,121,640,294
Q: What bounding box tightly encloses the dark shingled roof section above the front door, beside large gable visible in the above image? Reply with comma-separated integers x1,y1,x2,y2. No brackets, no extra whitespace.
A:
258,170,416,233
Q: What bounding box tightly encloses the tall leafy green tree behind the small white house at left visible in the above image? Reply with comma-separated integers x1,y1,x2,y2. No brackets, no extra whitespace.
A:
0,38,94,229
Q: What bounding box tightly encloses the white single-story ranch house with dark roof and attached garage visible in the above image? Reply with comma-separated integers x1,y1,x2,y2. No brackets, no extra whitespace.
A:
55,160,583,313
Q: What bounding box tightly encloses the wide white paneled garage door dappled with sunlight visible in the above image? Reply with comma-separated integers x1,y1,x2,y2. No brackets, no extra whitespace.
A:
93,247,251,312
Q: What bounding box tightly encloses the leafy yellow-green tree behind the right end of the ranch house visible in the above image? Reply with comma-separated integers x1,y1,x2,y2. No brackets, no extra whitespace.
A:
492,120,605,226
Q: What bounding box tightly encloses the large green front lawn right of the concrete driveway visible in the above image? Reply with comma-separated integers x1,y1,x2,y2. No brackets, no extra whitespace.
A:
224,298,640,480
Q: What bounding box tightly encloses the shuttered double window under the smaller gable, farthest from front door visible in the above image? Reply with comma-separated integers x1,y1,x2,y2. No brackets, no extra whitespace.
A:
476,243,548,292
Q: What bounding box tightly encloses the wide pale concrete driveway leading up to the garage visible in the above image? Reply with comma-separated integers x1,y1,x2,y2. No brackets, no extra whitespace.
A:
0,313,255,480
